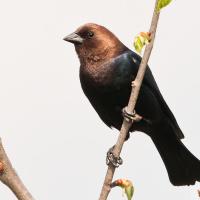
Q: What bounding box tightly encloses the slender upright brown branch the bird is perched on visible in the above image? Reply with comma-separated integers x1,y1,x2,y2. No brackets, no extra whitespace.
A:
99,0,160,200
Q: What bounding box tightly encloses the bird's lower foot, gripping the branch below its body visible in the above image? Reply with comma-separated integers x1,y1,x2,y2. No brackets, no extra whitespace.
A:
106,145,123,168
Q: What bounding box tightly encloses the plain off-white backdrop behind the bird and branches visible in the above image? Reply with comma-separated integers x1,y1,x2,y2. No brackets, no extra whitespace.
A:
0,0,200,200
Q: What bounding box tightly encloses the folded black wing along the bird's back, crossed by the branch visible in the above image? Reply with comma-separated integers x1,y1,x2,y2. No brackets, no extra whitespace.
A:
129,51,184,139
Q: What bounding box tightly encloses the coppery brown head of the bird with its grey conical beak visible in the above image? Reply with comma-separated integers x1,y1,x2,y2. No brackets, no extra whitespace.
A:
64,23,125,64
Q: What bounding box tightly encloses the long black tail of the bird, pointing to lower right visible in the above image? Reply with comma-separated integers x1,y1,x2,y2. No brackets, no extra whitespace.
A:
151,121,200,186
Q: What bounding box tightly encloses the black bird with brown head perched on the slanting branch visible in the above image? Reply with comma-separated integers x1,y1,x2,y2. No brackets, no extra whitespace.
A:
64,23,200,186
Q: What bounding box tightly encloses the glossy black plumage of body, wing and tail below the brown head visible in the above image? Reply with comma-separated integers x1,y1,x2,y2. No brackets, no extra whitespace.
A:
80,50,200,186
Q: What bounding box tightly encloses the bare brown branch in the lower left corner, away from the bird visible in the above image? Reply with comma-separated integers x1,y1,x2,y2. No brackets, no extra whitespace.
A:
0,139,34,200
